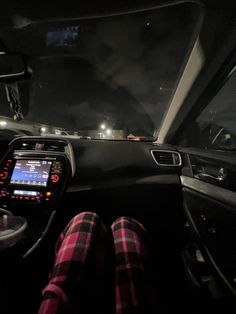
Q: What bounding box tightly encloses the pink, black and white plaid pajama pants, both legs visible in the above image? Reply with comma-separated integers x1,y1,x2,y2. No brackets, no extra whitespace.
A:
38,212,152,314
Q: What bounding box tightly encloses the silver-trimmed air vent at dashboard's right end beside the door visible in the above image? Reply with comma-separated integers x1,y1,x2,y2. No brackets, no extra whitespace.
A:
151,150,182,166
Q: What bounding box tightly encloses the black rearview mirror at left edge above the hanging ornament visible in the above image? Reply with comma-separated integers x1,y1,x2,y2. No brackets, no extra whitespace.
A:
0,53,26,81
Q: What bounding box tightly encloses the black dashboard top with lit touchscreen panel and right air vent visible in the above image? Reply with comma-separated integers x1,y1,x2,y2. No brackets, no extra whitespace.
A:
0,137,181,208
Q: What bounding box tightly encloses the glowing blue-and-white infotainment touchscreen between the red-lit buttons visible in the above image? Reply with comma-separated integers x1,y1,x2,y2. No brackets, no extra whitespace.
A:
10,159,52,186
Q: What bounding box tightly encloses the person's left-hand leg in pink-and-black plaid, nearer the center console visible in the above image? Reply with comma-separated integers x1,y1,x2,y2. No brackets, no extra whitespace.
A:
38,212,107,314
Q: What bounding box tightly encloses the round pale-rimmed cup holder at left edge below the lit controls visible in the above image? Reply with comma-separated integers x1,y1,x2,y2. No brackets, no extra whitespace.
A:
0,208,27,252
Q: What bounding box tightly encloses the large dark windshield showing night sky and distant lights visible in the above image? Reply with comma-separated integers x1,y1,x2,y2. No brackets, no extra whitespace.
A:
0,4,199,140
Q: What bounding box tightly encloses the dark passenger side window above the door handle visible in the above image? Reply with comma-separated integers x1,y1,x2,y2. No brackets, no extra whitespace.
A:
179,73,236,150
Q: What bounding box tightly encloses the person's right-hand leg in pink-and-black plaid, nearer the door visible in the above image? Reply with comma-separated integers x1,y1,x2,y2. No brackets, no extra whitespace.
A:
111,217,156,314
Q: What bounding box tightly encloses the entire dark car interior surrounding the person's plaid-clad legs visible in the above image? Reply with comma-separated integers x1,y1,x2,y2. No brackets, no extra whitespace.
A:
0,0,236,314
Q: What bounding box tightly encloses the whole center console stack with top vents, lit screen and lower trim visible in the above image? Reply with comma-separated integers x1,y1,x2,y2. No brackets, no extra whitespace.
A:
0,137,74,252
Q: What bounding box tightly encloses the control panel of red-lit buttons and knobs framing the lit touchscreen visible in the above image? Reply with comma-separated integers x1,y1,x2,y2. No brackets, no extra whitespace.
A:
0,155,68,210
